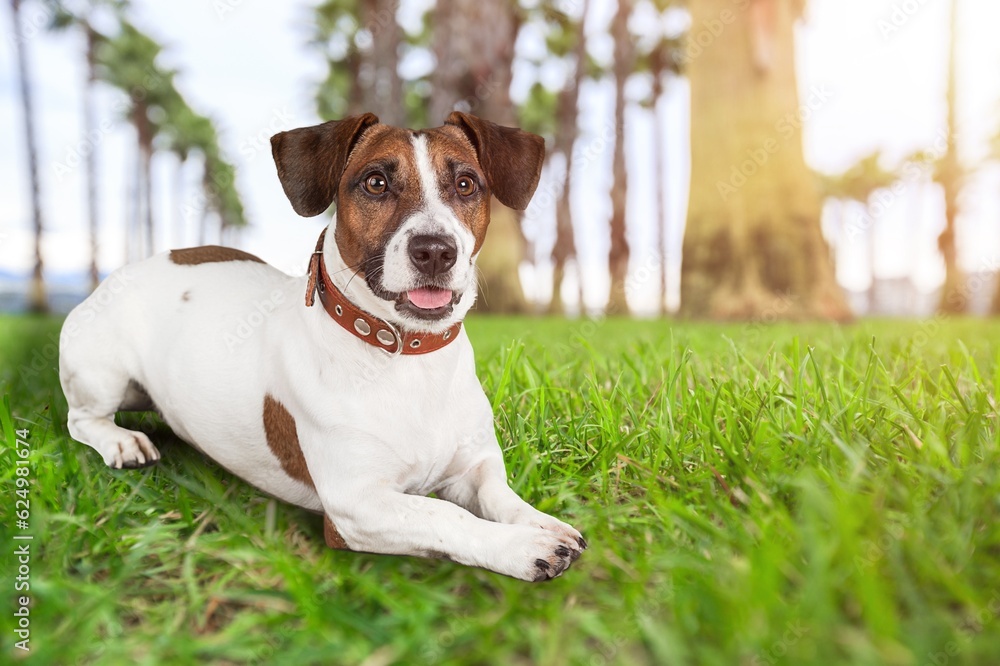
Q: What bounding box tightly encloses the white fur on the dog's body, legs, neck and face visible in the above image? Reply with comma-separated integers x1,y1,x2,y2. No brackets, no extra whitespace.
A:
60,141,581,580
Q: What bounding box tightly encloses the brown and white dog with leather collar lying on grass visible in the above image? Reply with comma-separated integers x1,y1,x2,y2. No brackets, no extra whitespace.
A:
59,112,587,581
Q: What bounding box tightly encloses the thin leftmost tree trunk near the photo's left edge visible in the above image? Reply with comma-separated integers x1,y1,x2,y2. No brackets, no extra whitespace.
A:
10,0,49,312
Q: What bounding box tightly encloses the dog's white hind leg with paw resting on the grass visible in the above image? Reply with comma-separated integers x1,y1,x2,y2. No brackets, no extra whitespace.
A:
59,358,160,469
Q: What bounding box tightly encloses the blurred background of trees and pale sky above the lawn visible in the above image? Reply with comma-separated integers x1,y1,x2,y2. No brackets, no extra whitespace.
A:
0,0,1000,321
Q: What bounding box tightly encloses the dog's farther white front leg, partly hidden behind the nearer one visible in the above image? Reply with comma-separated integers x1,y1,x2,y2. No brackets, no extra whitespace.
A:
438,455,587,550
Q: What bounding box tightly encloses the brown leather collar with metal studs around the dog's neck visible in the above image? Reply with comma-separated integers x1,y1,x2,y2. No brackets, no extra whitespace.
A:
306,229,462,354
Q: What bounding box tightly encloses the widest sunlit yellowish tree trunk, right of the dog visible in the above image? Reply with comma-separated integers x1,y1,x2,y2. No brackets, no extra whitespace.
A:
681,0,850,320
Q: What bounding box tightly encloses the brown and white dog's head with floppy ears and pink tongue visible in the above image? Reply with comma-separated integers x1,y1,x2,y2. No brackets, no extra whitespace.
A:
271,112,545,331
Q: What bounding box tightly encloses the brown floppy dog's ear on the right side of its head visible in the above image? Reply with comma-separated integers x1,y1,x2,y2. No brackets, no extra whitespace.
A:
444,111,545,210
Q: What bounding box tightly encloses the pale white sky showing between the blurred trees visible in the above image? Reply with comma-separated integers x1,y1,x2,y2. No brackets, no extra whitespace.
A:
0,0,1000,311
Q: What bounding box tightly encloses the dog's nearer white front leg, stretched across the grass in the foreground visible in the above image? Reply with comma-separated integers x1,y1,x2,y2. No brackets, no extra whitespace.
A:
323,487,580,581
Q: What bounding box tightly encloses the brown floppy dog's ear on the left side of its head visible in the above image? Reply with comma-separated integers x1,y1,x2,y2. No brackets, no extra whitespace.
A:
271,113,378,217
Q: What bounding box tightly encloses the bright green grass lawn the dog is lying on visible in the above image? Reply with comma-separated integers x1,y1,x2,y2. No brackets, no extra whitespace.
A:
0,318,1000,666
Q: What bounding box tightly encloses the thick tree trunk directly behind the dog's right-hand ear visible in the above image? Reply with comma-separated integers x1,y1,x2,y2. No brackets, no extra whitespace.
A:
430,0,527,312
